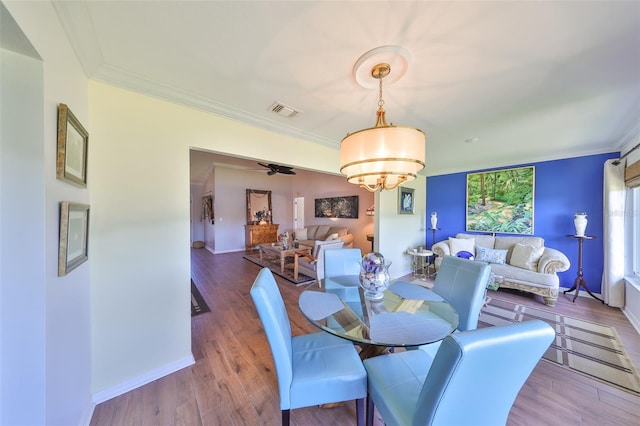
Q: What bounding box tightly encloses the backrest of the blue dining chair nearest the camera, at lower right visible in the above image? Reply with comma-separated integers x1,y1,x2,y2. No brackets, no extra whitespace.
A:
413,320,555,425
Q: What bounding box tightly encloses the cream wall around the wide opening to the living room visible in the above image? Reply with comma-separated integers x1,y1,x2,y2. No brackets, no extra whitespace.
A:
89,82,350,401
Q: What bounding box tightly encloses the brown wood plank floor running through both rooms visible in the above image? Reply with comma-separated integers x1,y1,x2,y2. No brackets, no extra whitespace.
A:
91,249,640,426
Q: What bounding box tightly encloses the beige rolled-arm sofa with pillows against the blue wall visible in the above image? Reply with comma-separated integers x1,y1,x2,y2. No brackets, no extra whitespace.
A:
431,234,571,306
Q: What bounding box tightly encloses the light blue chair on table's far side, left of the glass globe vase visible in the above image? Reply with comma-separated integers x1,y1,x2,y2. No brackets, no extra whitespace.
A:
324,248,362,303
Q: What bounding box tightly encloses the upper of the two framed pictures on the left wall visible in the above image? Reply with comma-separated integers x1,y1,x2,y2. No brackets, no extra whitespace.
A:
56,104,89,188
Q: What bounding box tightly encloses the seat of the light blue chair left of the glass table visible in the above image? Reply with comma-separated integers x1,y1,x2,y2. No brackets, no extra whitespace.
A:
290,332,367,409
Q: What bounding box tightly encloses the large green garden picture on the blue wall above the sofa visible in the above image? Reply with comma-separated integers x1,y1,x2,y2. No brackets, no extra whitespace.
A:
466,166,535,235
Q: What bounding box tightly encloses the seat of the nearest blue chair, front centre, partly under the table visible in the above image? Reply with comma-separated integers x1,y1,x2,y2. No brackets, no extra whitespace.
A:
364,350,433,425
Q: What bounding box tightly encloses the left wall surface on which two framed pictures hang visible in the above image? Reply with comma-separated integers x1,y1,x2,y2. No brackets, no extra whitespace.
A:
0,1,93,424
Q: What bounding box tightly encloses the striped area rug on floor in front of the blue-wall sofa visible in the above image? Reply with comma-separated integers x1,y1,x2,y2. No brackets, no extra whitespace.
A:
478,296,640,394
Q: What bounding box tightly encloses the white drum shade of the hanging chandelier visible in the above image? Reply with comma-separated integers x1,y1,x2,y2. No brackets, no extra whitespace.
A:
340,126,426,189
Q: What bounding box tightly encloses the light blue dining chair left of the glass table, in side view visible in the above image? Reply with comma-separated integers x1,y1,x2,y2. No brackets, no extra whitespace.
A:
251,268,367,426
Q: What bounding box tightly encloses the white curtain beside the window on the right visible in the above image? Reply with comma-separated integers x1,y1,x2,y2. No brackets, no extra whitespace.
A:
602,160,626,308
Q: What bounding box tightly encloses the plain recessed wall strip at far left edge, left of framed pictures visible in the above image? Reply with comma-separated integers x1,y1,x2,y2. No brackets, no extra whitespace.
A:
0,49,46,424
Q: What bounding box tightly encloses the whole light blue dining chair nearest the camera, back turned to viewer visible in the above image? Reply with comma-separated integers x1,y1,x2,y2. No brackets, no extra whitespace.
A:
364,320,555,426
